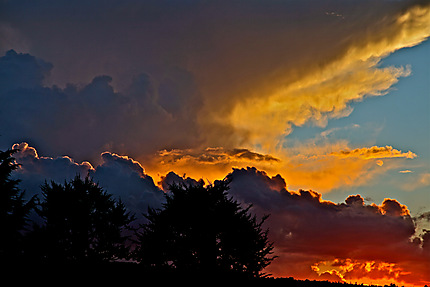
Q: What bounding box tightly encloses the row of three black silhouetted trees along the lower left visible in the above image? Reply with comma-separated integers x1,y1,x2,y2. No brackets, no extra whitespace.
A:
0,150,275,278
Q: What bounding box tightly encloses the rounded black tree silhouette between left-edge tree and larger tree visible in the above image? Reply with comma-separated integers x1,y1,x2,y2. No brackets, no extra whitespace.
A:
35,176,134,263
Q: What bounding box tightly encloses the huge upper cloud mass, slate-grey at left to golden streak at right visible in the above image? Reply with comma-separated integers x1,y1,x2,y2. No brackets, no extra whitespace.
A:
2,0,430,160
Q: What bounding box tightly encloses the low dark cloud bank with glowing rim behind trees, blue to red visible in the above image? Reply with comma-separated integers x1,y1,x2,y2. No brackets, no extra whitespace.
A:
13,143,430,285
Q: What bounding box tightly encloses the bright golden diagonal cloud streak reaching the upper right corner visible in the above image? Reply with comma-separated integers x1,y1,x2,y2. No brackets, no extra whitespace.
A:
202,5,430,152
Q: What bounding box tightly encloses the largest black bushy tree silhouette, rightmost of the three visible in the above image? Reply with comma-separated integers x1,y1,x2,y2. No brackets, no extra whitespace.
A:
135,180,274,277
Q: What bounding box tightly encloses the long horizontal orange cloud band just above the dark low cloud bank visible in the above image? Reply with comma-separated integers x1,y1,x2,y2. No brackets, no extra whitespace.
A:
144,142,416,192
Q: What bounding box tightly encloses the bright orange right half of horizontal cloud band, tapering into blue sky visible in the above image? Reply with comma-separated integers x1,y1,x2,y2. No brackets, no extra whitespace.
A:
278,144,417,193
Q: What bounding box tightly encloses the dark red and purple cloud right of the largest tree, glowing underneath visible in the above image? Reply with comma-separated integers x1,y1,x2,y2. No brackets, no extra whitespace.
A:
227,168,430,284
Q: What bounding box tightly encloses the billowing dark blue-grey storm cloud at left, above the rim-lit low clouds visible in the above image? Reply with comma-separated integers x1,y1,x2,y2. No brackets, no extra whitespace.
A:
0,50,202,162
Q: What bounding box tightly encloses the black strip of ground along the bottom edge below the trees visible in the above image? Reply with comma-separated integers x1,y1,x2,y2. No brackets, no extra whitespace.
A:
4,263,400,287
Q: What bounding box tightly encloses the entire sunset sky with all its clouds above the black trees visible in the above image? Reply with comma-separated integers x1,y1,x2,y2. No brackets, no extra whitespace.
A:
0,0,430,286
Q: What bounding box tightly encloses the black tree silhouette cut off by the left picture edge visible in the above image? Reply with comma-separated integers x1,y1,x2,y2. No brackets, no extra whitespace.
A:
0,150,34,262
